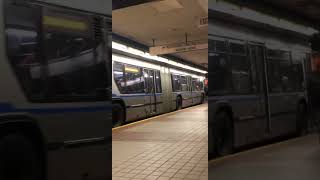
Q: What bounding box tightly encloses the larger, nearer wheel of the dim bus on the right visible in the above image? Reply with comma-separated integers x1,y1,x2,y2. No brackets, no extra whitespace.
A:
213,112,233,156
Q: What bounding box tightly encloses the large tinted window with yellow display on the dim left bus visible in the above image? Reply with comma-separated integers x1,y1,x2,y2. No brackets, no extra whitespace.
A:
43,9,108,99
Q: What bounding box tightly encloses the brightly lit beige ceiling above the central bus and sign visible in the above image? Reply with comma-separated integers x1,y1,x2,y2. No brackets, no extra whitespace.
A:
112,0,208,68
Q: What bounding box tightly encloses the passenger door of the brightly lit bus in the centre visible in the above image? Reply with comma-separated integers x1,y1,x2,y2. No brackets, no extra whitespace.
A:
143,69,157,116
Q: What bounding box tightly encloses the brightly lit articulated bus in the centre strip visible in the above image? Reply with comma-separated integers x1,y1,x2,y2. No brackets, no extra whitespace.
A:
112,42,206,127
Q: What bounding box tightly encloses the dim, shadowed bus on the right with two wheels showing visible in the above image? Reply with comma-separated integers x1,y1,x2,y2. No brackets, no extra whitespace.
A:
208,17,311,157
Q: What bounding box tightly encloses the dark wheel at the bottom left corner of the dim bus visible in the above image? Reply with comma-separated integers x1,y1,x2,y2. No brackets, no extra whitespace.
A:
0,134,43,180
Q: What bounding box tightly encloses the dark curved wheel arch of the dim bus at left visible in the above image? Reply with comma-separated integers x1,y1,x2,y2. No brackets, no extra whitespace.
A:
0,117,47,179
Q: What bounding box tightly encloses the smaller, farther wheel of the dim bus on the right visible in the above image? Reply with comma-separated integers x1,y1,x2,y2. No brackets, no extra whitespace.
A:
297,103,308,136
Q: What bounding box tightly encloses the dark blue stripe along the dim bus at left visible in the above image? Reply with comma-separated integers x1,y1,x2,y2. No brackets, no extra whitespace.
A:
0,103,112,114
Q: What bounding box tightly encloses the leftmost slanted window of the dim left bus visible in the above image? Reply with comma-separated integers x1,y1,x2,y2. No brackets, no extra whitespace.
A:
5,2,45,99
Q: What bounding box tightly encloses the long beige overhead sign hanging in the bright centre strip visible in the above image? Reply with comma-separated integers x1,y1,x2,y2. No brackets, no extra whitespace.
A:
149,43,208,56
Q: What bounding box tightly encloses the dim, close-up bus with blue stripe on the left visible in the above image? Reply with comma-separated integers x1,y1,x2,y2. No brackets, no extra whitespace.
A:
0,0,112,180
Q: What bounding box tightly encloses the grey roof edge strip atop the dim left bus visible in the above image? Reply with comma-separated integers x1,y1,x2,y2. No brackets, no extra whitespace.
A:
38,0,112,16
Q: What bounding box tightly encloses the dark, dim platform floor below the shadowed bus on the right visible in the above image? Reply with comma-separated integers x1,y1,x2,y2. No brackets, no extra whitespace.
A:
209,134,320,180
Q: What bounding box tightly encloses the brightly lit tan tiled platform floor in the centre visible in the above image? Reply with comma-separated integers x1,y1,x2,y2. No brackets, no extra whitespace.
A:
112,104,208,180
